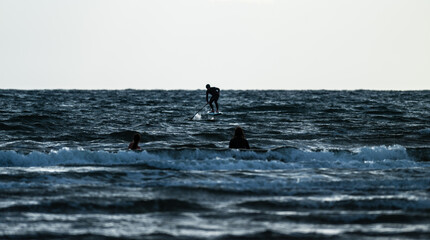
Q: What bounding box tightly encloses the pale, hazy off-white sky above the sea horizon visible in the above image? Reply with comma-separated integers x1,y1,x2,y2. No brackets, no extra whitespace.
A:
0,0,430,90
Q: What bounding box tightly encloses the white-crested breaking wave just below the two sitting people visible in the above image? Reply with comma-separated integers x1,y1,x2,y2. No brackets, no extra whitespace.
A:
0,145,430,170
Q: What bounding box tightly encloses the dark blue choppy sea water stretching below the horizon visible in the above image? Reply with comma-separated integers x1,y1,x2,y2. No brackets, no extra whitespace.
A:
0,90,430,240
